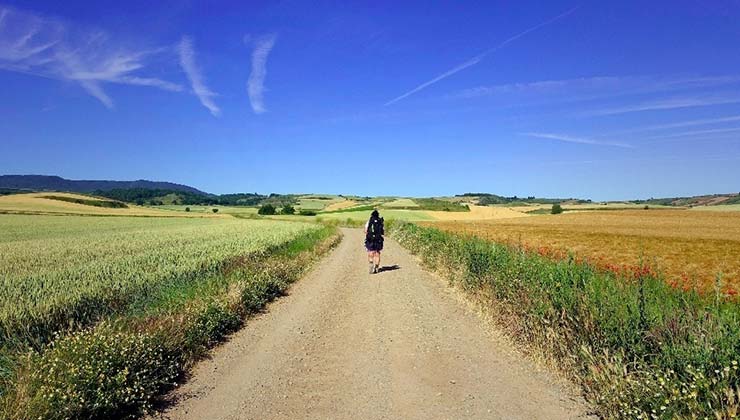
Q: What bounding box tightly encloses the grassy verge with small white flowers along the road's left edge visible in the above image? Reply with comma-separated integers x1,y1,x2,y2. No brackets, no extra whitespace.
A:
0,226,339,420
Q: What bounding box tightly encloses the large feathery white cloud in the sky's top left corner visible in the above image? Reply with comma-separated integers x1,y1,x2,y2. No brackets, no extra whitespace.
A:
0,6,182,108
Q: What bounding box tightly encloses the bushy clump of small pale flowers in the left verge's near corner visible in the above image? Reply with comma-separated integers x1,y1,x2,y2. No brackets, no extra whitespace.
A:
29,325,180,419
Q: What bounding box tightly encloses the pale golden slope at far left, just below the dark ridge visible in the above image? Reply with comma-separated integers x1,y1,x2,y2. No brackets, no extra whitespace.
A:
0,192,215,217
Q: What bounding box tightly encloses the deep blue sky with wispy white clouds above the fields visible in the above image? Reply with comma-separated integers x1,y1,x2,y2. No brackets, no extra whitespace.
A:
0,1,740,200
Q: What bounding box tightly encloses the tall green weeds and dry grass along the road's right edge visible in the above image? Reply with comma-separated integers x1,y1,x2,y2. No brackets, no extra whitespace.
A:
393,221,740,419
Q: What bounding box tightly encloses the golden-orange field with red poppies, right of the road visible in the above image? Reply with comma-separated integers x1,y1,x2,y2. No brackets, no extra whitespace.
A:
424,210,740,289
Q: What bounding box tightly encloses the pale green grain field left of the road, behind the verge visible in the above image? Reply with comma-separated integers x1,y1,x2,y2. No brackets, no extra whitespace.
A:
0,215,319,344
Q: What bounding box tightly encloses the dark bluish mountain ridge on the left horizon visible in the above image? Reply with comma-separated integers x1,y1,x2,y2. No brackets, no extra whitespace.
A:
0,175,208,195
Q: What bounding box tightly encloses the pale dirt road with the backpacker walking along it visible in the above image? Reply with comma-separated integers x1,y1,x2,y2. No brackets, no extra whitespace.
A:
156,229,586,420
